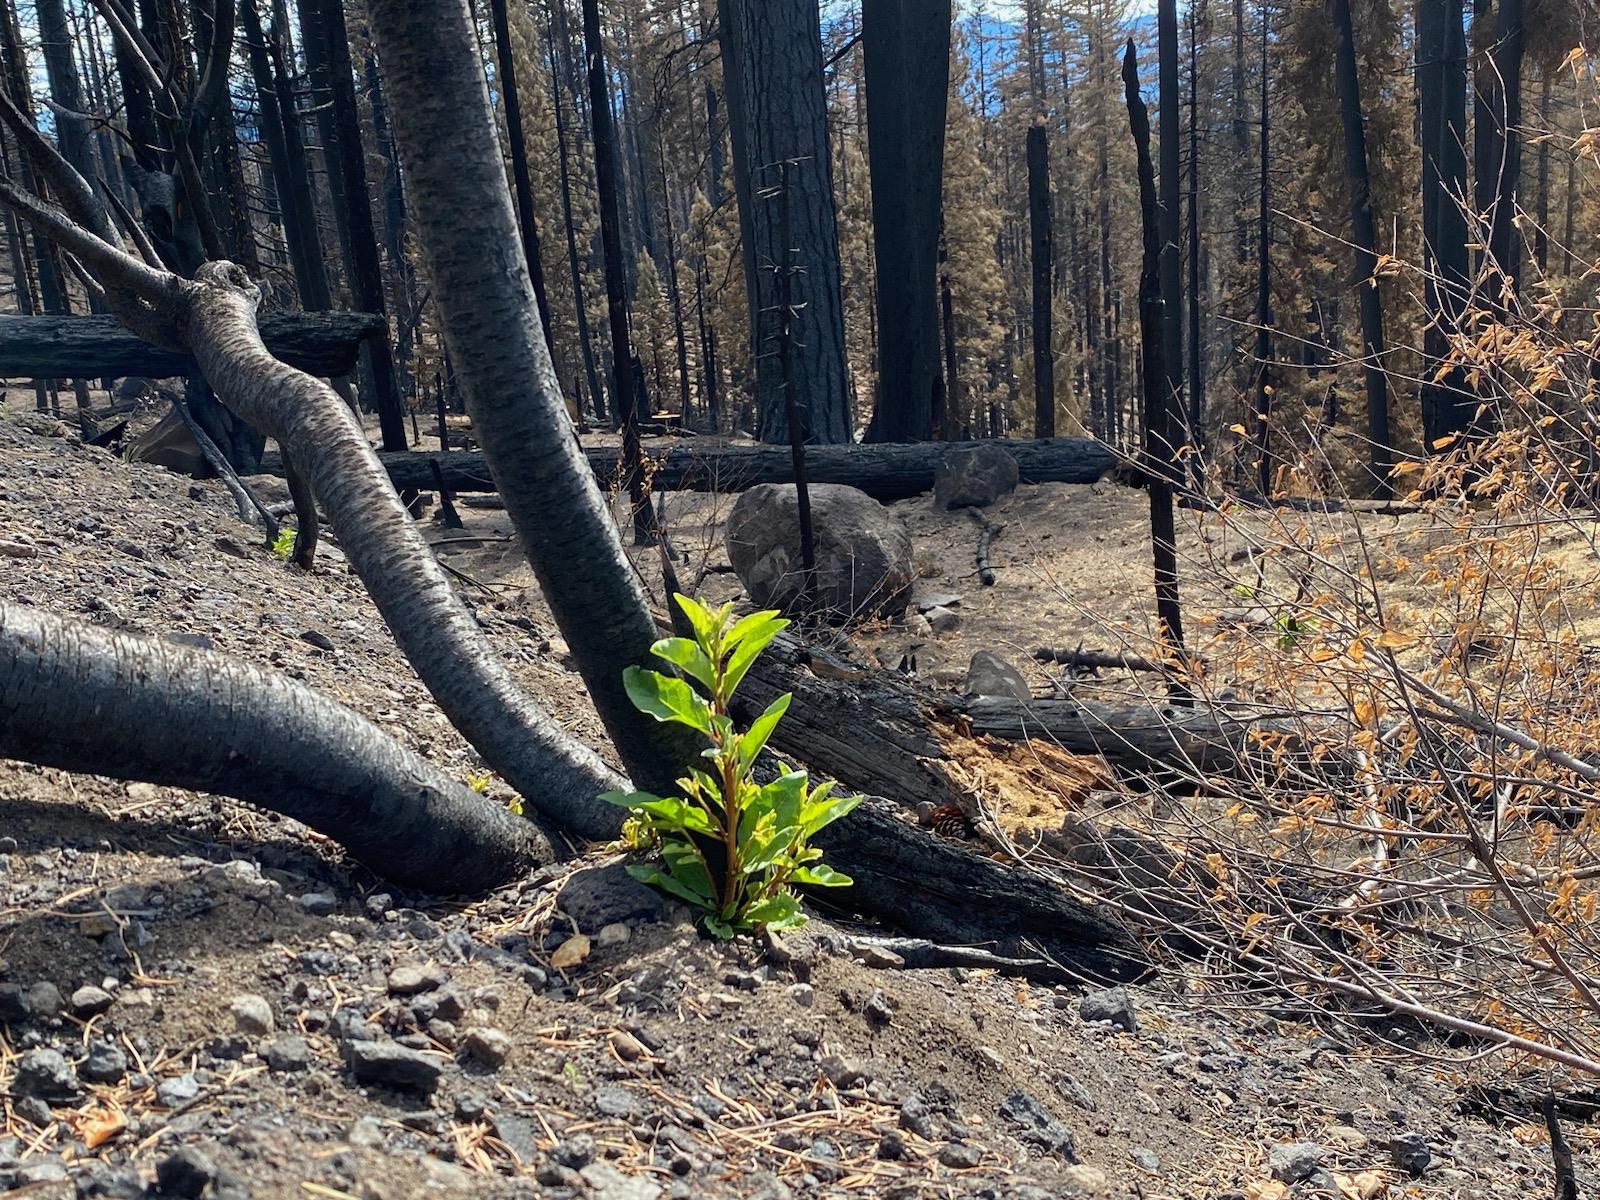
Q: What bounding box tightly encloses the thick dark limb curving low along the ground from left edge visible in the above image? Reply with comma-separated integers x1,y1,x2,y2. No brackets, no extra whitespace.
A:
0,602,554,893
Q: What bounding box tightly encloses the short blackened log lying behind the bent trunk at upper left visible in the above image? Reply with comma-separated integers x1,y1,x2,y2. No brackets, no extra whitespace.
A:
0,312,384,377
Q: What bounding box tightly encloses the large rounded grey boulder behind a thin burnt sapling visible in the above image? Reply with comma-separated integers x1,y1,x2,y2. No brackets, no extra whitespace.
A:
725,483,914,621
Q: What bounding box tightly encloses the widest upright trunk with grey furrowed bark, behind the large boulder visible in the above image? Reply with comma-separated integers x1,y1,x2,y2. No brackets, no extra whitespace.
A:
718,0,857,445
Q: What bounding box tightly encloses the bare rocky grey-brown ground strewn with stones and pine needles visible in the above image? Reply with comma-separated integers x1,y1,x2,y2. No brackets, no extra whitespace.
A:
0,397,1594,1200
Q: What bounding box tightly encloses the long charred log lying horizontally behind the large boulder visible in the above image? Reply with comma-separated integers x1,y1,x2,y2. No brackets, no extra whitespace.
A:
262,437,1117,501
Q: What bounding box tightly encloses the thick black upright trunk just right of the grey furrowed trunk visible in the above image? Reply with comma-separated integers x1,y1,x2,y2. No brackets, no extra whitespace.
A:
861,0,950,442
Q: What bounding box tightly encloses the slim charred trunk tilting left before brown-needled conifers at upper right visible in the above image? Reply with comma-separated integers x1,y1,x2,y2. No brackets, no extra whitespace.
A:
1330,0,1394,499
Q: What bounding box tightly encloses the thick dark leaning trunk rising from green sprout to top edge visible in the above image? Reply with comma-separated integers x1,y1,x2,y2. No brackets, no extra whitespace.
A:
371,0,704,812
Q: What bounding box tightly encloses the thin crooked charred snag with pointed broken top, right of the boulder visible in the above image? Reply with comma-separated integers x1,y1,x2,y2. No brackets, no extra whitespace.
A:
1122,38,1189,701
